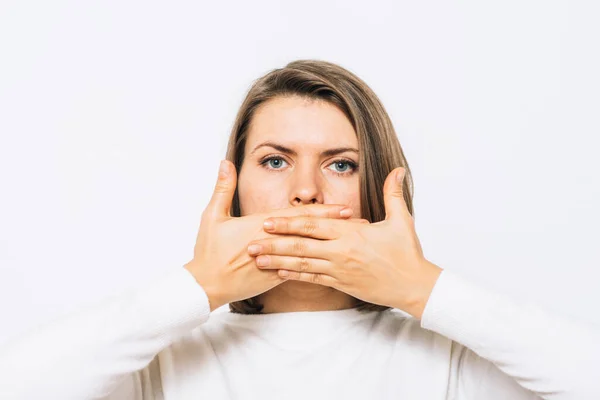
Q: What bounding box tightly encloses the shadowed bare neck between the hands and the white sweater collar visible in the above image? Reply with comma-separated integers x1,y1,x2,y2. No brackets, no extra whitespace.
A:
259,281,357,314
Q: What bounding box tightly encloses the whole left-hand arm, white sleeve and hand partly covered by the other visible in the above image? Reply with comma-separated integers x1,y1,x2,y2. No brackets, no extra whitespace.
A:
0,160,348,400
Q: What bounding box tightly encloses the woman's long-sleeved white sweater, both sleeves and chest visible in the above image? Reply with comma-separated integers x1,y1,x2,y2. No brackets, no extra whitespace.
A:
0,268,600,400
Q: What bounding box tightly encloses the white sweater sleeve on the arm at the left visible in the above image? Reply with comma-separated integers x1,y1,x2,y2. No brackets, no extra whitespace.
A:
0,268,210,400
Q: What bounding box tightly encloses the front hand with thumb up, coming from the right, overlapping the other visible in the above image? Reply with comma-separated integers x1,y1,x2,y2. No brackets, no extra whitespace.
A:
249,168,442,319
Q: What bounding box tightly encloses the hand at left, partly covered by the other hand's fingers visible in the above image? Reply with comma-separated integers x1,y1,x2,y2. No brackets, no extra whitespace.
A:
185,160,352,311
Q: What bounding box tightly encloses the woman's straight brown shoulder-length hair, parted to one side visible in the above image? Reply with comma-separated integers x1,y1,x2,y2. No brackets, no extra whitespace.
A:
226,60,413,314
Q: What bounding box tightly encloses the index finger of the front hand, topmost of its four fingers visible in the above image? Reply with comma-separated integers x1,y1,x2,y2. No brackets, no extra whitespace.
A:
264,217,369,240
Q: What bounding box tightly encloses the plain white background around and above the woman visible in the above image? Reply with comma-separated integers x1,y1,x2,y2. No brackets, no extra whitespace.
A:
0,1,600,342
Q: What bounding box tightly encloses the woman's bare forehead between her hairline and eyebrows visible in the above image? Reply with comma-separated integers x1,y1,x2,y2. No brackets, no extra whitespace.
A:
246,96,358,151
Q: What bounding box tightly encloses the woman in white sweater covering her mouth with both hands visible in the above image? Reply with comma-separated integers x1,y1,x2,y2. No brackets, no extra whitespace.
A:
0,60,600,400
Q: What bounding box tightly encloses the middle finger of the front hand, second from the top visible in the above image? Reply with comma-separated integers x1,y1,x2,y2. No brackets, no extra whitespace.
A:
248,236,328,259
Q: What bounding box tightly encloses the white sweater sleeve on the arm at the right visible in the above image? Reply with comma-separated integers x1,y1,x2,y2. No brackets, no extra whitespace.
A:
421,269,600,400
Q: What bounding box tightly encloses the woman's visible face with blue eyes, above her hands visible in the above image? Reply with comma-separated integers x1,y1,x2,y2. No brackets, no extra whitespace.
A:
238,96,360,218
